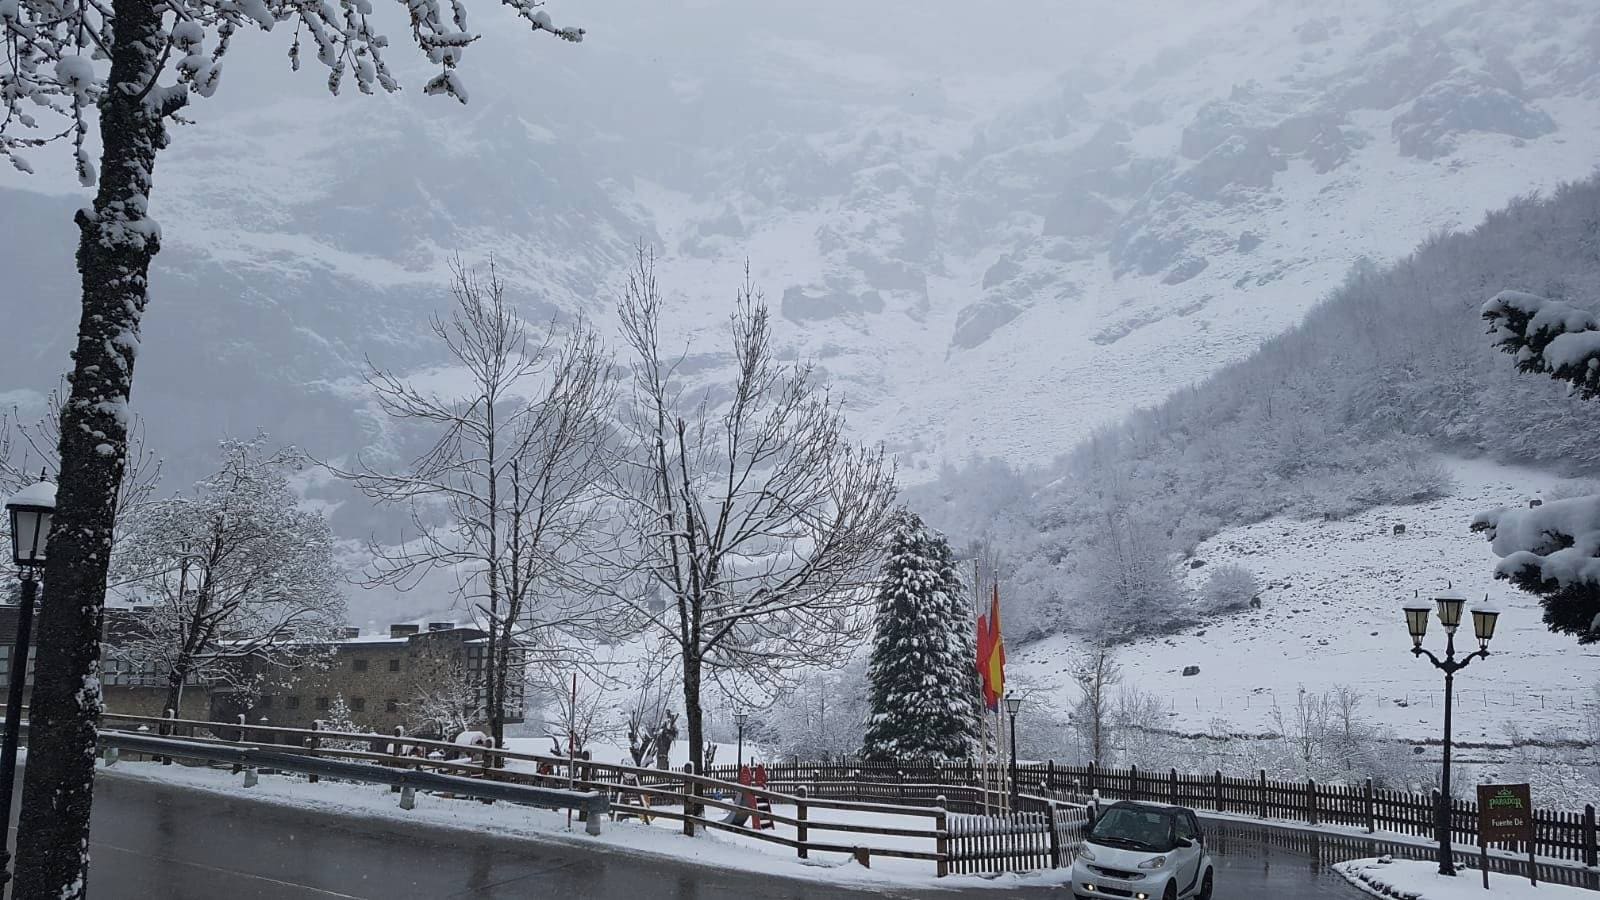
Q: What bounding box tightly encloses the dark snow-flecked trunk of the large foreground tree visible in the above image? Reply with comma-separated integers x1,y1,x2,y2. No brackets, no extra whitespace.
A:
14,0,187,900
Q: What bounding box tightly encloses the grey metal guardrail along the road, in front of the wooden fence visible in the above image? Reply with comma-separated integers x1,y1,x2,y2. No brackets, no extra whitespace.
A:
99,730,611,834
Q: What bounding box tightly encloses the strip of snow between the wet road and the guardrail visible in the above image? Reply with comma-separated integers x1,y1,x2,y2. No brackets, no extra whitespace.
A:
96,762,1070,890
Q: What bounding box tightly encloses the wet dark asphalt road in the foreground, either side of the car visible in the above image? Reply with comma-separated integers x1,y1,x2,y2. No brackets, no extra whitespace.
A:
9,762,1363,900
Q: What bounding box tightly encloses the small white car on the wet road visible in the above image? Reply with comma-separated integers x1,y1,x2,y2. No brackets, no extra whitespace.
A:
1072,801,1213,900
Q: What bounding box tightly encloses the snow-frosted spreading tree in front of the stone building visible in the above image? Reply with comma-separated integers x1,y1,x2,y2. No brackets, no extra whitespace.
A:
112,436,346,711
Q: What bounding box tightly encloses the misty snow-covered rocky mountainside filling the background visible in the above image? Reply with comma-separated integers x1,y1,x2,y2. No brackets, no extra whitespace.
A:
0,0,1600,614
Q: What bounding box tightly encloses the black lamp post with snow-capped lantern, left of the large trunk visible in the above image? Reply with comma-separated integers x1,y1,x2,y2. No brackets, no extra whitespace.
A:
0,476,56,889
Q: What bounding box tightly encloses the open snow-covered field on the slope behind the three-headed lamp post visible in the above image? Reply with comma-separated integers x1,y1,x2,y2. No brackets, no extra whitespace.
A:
1011,460,1600,741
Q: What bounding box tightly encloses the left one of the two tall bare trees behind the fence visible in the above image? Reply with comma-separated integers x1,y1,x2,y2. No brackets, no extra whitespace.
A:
330,261,611,746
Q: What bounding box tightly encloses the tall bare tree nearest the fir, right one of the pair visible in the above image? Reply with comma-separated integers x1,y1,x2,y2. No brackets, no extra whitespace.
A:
605,248,894,770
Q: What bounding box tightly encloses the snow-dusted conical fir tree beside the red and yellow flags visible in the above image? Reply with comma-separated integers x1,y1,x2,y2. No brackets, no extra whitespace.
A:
862,509,981,761
